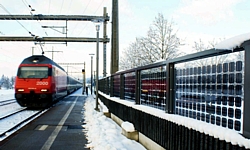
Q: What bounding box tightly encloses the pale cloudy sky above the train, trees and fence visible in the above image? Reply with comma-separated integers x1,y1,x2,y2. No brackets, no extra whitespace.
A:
0,0,250,78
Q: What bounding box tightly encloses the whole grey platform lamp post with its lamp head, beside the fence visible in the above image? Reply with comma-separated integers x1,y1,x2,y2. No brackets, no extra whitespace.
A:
92,18,104,110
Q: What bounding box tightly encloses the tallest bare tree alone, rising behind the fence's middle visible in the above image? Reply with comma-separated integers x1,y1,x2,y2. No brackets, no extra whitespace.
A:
141,14,181,63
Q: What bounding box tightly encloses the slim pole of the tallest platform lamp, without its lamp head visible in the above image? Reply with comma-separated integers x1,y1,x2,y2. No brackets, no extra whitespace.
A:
95,24,100,110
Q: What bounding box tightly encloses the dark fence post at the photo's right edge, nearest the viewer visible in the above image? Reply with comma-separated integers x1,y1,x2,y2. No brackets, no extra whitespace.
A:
243,44,250,138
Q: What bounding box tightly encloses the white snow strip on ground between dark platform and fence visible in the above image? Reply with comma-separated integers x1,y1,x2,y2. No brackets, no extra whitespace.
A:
84,96,146,150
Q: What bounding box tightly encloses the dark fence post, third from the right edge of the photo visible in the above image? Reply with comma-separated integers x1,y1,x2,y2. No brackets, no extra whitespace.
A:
135,70,141,104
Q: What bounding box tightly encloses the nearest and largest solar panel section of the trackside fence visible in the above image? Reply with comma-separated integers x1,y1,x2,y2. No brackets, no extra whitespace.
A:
175,58,244,132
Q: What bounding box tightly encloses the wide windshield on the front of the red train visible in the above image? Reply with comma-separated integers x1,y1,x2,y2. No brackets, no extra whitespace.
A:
17,67,50,78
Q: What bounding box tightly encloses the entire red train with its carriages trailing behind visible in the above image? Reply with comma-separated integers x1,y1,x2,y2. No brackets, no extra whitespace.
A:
15,55,82,107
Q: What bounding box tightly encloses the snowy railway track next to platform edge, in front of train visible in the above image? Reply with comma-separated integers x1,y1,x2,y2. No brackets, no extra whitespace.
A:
0,108,46,141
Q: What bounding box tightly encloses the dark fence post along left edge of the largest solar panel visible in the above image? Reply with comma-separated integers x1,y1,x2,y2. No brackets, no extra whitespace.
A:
166,63,175,114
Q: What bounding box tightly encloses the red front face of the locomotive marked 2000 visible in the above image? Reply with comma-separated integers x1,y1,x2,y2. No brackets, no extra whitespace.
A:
15,64,54,107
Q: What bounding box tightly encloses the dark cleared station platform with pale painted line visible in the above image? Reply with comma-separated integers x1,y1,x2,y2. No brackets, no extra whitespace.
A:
0,91,88,150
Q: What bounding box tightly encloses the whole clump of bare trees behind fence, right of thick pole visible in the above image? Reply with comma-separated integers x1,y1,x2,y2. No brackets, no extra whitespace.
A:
120,13,182,69
